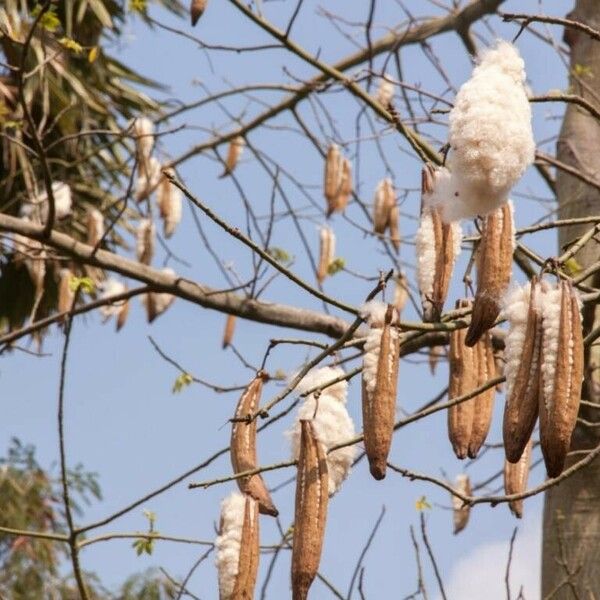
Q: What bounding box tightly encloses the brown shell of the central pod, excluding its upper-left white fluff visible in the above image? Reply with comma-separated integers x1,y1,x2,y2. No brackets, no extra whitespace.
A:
362,304,400,480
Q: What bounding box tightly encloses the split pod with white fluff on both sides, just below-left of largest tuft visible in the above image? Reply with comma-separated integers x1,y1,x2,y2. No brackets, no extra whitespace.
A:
415,167,462,321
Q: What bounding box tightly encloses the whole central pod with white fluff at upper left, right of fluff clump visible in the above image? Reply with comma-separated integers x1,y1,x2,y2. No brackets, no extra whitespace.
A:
361,301,400,479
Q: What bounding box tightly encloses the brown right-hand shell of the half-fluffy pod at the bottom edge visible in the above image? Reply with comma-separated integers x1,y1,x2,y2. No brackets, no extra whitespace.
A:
230,496,260,600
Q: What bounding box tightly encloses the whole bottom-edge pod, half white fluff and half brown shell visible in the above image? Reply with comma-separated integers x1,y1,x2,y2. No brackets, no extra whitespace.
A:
215,492,260,600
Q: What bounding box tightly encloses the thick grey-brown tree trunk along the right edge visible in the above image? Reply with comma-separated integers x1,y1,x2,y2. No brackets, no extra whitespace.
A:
542,0,600,600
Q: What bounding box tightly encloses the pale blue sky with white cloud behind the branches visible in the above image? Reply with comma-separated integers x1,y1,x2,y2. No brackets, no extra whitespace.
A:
0,0,571,599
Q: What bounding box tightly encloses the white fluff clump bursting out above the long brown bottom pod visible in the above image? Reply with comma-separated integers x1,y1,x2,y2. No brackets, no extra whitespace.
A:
286,367,356,496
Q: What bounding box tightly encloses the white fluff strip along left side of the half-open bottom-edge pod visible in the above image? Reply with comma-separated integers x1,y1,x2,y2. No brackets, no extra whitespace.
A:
215,492,246,600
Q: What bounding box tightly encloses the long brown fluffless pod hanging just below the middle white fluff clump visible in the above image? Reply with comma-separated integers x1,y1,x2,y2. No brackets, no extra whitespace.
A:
292,421,329,600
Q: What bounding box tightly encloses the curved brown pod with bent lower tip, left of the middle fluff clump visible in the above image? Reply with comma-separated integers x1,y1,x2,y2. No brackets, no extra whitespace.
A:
230,371,279,517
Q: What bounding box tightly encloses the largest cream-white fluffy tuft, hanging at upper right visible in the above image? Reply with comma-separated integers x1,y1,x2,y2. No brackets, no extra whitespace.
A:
428,41,535,222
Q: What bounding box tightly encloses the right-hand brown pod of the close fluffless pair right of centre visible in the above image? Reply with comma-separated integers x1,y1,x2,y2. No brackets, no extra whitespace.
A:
468,331,496,458
